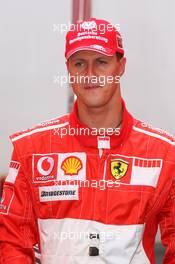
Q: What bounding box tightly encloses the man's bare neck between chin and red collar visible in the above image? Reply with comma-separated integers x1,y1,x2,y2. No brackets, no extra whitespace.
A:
77,96,122,129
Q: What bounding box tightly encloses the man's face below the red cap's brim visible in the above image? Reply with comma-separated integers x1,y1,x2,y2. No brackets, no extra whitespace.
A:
67,50,126,107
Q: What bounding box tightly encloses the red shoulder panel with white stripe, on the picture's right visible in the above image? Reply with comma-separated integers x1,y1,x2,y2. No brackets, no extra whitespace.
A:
133,119,175,145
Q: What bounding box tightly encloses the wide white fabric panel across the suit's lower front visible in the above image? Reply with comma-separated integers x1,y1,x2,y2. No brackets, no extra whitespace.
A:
38,218,150,264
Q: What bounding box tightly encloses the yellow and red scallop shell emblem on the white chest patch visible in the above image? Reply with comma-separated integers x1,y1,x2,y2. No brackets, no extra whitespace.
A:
61,156,83,175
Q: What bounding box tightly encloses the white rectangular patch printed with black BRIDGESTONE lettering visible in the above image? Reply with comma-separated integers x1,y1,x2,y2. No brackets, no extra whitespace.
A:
39,185,79,202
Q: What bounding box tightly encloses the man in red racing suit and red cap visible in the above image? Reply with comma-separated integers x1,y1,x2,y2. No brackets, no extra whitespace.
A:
0,19,175,264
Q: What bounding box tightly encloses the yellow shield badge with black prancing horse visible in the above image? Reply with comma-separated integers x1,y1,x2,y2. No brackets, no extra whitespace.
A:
111,159,128,180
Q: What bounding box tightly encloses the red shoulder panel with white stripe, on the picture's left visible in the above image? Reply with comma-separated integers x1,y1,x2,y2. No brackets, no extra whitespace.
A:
10,114,69,143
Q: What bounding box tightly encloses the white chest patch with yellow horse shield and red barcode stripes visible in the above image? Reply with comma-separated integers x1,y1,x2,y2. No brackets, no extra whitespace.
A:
108,154,163,187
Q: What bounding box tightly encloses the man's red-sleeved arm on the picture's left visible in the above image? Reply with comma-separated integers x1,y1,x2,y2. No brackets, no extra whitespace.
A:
0,151,37,264
